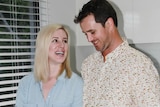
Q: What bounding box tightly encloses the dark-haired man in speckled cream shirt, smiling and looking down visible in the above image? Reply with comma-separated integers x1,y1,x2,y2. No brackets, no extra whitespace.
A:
74,0,160,107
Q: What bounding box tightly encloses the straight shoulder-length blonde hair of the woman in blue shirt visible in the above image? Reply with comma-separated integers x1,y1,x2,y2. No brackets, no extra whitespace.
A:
34,24,72,81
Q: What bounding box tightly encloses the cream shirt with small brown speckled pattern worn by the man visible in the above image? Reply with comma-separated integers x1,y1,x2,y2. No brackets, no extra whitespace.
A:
81,41,160,107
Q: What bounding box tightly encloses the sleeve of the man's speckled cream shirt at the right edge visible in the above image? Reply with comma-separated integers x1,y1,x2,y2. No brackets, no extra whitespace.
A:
132,63,160,107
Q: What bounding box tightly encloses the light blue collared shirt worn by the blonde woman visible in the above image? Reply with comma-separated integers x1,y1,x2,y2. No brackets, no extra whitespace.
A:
15,72,83,107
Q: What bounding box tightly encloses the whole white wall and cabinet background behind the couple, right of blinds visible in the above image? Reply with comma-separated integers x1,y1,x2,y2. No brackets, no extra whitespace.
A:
47,0,160,71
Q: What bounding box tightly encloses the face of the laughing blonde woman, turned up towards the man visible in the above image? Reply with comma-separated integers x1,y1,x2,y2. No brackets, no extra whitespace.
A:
48,29,68,64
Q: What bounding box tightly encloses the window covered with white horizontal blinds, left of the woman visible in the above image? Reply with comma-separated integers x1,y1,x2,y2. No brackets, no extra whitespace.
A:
0,0,47,107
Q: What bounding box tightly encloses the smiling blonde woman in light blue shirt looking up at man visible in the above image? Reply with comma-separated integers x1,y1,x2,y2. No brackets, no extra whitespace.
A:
16,24,83,107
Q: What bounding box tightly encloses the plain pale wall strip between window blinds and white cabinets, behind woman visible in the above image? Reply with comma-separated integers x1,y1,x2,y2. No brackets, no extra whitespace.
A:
48,0,79,72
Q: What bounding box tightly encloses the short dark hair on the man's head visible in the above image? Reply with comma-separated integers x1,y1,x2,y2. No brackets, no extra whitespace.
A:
74,0,118,26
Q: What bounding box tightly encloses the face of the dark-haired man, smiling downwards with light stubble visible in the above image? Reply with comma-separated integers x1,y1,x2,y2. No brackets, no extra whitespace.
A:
80,14,110,52
